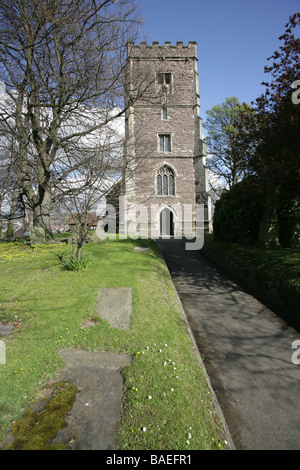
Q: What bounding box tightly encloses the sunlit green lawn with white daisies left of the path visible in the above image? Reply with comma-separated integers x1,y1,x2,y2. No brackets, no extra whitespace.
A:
0,239,226,450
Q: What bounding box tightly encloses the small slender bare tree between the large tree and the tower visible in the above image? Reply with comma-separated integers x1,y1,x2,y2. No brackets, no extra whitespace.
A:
54,110,124,261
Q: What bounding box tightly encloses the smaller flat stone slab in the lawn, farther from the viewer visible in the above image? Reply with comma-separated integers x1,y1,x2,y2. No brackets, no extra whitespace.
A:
96,287,132,330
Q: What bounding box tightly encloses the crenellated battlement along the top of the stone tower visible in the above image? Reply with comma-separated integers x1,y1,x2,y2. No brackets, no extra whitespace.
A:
127,41,197,59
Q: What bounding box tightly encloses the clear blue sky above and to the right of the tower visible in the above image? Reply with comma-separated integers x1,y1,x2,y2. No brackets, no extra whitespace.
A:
139,0,299,127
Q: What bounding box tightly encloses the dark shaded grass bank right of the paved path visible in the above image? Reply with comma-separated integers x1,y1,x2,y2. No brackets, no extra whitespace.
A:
202,235,300,328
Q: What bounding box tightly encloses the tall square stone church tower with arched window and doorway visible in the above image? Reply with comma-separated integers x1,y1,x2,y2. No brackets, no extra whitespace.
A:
120,42,210,238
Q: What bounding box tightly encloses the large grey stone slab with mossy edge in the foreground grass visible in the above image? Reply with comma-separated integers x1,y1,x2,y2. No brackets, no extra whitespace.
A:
53,349,131,450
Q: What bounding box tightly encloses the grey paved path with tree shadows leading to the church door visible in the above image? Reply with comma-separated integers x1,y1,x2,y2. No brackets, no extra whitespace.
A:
157,239,300,450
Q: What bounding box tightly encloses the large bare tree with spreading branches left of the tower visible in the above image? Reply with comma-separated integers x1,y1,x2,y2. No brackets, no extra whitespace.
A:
0,0,140,241
